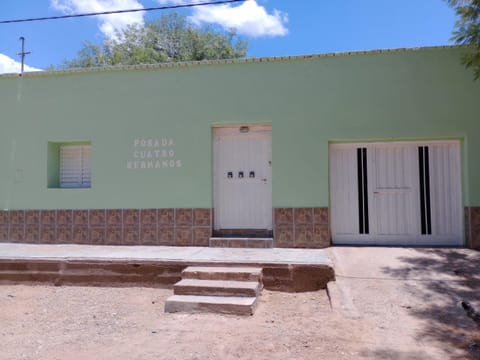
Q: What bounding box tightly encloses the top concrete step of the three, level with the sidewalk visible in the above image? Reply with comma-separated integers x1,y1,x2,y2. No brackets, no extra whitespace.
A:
182,266,262,281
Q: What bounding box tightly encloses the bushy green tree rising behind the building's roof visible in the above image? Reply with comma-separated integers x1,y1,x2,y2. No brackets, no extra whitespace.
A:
62,13,248,68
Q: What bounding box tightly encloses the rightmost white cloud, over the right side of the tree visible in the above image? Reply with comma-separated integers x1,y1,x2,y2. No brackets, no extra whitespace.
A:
157,0,288,37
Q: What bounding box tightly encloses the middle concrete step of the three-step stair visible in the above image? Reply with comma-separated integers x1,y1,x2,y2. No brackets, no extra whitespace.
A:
173,279,261,297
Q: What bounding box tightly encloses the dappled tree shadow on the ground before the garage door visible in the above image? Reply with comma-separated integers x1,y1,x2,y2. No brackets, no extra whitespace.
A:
382,249,480,359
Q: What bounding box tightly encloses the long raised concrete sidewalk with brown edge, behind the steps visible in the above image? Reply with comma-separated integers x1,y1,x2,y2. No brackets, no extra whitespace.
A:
0,244,335,292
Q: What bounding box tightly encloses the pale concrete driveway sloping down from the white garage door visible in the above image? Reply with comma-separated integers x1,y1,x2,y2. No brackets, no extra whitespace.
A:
326,247,480,359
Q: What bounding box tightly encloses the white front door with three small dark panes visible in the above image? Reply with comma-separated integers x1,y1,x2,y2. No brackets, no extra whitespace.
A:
213,126,272,230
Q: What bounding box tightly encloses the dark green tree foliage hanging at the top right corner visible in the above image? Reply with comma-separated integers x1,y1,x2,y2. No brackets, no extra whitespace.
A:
447,0,480,80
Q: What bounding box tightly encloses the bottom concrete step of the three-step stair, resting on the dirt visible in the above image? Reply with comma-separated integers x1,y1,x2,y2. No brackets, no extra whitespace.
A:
165,295,257,315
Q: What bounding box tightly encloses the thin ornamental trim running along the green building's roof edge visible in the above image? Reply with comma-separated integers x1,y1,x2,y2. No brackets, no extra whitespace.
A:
0,45,469,78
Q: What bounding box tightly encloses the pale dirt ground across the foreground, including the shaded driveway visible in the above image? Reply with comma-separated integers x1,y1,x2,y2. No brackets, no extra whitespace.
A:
0,247,480,360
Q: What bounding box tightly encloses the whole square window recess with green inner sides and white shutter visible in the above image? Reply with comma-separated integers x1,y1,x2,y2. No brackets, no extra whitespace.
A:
47,141,92,189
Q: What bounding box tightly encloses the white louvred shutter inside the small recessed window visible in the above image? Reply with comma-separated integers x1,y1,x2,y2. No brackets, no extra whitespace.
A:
60,145,91,188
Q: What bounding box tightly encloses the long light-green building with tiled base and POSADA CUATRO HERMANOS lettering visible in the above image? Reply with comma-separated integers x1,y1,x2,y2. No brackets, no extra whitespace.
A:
0,47,480,248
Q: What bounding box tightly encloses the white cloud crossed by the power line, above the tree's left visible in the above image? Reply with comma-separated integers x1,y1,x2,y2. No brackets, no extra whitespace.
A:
50,0,144,37
